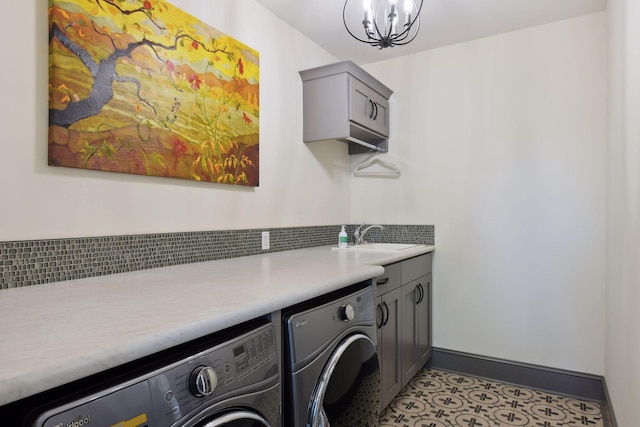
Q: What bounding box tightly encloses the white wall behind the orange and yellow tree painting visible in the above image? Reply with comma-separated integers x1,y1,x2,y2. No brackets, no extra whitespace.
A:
0,0,350,241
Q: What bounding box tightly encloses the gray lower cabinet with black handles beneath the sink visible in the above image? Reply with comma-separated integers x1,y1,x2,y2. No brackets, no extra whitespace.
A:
376,253,432,408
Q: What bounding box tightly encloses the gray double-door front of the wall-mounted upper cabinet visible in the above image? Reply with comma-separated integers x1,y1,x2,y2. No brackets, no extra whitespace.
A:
349,77,389,136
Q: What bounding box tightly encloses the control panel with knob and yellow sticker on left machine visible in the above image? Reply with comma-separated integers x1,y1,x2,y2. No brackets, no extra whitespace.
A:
33,324,279,427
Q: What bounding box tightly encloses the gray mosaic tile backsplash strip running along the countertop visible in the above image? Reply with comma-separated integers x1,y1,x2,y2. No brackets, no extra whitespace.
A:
0,225,435,289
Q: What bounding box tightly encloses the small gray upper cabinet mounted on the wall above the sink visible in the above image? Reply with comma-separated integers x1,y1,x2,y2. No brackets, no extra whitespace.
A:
300,61,393,154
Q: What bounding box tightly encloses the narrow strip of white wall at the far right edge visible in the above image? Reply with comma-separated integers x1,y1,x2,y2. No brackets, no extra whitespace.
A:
605,0,640,427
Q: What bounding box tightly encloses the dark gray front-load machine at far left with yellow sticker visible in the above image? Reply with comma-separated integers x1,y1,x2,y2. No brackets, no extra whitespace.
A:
25,320,281,427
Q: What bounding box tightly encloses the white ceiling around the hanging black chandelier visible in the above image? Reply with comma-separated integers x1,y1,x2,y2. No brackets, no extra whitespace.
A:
256,0,607,65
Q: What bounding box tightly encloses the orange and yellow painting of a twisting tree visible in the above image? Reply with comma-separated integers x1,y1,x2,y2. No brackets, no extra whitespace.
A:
49,0,260,186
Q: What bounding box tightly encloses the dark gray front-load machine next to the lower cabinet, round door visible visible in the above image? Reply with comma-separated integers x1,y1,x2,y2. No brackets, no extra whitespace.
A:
283,282,380,427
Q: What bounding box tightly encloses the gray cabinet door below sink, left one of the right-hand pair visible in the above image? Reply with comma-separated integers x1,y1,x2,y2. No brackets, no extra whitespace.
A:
400,280,420,387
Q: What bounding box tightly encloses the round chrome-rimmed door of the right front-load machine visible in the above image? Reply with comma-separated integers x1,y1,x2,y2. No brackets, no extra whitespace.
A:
307,333,380,427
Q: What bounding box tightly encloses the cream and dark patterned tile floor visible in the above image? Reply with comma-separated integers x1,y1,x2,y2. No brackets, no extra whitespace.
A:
379,369,604,427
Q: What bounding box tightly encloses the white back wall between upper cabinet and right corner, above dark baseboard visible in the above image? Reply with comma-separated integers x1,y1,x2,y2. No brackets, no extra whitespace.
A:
352,13,607,374
